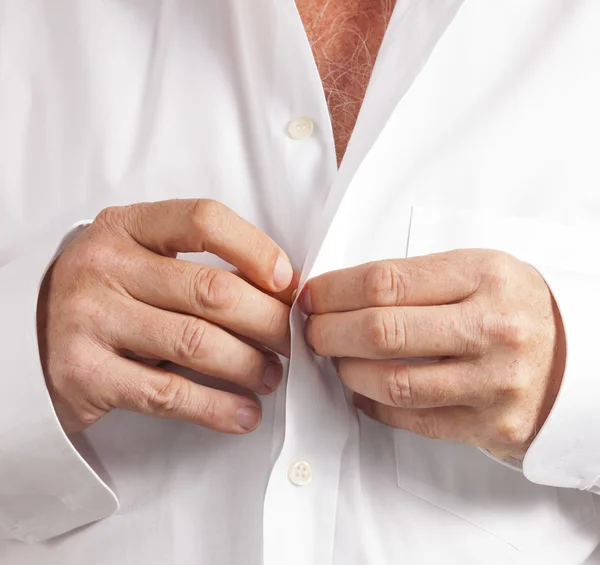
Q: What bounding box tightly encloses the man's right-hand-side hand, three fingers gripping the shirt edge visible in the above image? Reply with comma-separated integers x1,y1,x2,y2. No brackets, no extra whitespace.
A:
299,250,565,457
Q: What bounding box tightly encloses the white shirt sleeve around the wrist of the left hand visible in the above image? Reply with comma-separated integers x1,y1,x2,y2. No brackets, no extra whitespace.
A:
0,220,118,542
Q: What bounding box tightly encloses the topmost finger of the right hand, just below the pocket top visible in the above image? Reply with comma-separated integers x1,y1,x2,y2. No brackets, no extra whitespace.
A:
299,249,482,314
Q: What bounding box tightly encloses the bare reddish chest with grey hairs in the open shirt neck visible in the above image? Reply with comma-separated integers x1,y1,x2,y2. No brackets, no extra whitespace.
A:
296,0,395,164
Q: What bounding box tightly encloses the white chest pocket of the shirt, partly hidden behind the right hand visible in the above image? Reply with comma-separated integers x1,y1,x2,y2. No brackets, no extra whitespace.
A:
394,207,597,549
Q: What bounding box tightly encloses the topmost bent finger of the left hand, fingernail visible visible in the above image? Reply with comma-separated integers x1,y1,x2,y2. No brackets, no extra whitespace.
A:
99,199,293,292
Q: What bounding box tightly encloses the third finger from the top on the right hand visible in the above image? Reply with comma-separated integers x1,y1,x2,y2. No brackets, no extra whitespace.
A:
338,358,488,408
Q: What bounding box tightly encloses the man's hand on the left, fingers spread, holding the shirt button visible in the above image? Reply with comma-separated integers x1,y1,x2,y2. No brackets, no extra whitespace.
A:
38,200,295,433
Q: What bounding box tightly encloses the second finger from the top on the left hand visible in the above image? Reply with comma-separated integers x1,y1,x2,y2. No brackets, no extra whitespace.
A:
122,251,290,356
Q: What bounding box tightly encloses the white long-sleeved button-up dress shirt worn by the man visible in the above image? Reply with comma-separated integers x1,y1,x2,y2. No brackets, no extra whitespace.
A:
0,0,600,565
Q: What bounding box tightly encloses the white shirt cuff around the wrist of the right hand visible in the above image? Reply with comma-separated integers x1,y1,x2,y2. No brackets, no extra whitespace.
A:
523,269,600,490
